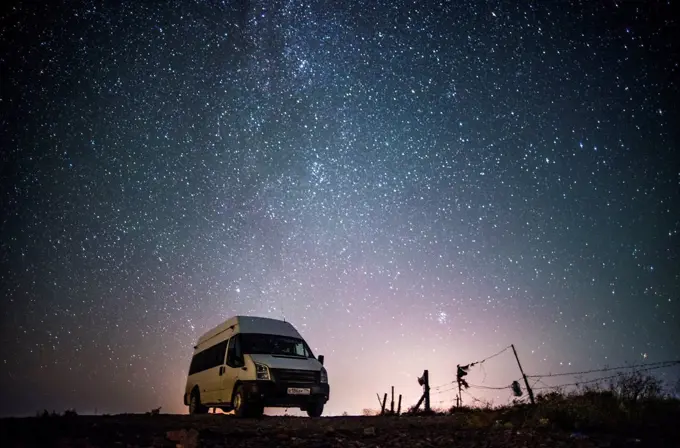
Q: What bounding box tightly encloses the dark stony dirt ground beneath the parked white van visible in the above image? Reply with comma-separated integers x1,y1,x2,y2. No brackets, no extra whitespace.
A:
0,414,680,448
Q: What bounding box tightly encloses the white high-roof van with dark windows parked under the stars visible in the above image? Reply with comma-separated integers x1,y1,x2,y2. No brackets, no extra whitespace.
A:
184,316,329,417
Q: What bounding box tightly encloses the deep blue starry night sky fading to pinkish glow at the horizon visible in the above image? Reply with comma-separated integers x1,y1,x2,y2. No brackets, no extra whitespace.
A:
0,0,680,415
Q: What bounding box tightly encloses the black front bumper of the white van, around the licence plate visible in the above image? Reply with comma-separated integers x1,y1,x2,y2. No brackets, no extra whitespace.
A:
241,381,330,407
